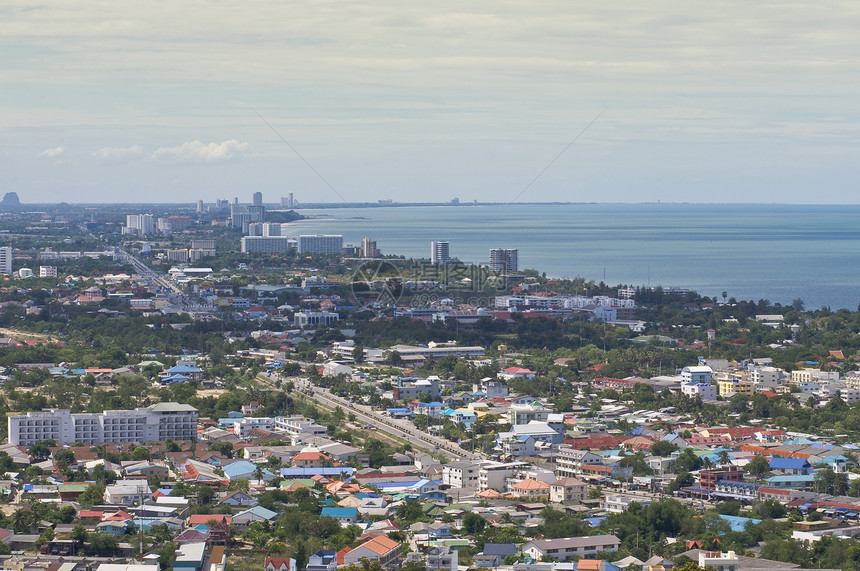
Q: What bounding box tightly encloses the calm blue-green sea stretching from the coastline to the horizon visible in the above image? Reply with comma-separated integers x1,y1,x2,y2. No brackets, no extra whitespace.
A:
291,204,860,310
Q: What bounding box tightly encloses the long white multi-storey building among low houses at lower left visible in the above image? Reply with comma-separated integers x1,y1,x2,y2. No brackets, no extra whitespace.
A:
7,402,197,447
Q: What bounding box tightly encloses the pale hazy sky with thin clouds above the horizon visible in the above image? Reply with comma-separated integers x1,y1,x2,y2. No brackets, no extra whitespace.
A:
0,0,860,203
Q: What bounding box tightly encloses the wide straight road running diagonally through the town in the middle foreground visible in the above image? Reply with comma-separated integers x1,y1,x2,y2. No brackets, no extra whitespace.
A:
286,378,481,460
